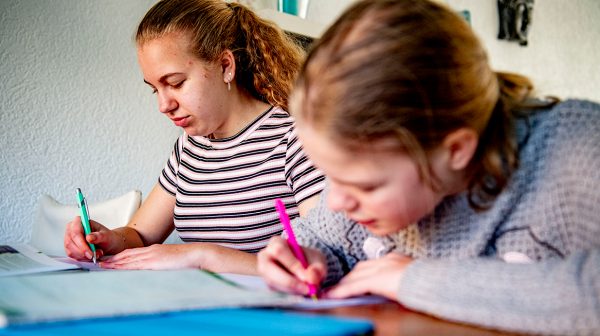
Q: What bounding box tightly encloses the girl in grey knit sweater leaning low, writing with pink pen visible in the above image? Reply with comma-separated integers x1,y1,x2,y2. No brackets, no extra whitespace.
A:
258,0,600,335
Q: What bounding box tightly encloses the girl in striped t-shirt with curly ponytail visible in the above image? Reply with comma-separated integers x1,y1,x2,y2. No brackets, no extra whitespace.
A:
65,0,324,274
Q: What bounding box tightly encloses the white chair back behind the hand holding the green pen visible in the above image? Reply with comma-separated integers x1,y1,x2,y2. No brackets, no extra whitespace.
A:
30,190,142,257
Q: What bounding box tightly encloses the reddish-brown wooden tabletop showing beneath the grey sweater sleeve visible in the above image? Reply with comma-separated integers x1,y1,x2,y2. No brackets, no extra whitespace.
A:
314,302,514,336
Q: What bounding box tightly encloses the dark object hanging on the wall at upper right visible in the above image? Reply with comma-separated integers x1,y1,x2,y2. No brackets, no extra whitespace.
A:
498,0,533,46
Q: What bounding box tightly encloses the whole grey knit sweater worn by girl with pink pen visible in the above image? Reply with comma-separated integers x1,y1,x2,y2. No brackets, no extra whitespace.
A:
294,100,600,335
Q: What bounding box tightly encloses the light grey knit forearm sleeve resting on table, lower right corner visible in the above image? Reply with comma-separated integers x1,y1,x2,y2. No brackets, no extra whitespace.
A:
398,249,600,335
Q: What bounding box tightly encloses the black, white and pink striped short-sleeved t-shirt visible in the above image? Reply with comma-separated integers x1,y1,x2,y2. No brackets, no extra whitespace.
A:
159,107,324,252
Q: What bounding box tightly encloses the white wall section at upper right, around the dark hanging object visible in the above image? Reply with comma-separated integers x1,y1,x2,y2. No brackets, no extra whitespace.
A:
445,0,600,101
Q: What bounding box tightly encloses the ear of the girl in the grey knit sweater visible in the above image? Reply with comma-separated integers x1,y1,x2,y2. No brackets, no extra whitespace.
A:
442,128,479,171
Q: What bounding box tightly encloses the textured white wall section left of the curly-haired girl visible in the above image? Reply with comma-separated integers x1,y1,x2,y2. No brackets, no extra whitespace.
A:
0,0,180,242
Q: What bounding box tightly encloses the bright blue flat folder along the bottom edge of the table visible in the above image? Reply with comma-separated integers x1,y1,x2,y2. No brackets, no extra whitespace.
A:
0,309,373,336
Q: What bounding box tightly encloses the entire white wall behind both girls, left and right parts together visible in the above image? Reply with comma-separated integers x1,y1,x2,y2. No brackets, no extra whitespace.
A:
0,0,600,242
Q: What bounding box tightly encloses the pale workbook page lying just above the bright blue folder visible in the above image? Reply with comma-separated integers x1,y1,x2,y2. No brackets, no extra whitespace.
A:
0,270,302,326
